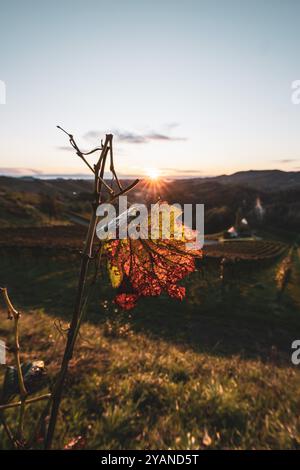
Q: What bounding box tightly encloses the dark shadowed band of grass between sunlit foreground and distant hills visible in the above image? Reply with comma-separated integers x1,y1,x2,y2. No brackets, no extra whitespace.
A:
0,249,300,365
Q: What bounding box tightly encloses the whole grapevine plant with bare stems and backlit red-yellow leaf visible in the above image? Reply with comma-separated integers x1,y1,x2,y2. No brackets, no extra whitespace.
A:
0,126,201,449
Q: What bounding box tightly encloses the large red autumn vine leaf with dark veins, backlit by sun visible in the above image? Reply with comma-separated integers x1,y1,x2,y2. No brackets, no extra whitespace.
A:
106,201,201,310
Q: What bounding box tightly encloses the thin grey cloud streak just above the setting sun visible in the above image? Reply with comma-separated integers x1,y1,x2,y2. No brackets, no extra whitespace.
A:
83,124,187,144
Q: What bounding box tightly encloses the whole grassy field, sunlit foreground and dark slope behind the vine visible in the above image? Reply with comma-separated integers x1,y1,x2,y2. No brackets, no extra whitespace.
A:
0,226,300,449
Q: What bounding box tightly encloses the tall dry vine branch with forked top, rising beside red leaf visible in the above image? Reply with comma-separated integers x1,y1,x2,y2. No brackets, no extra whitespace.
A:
45,126,138,449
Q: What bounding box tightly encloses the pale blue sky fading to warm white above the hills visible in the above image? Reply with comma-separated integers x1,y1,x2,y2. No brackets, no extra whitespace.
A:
0,0,300,177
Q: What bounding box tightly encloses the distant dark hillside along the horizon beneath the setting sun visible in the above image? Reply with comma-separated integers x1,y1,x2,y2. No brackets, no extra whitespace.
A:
0,170,300,233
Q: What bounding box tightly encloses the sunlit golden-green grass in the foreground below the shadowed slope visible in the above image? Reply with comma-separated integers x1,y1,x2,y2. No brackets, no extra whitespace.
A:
0,311,300,449
